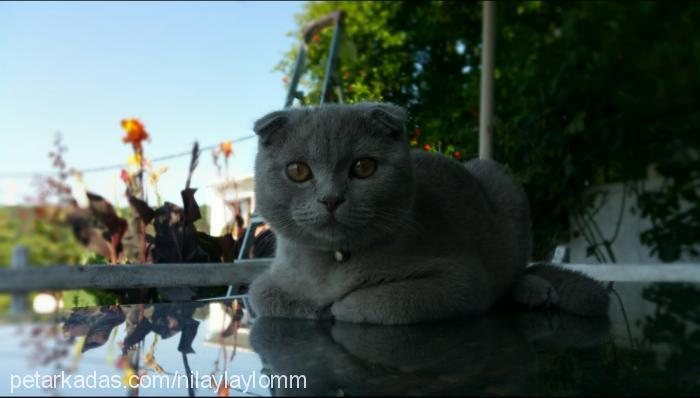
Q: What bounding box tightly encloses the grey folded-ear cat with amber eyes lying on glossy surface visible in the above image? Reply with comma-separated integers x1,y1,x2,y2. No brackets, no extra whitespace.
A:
250,103,609,324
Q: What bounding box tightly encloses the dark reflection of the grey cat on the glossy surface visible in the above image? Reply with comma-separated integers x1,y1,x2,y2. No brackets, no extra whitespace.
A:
251,312,610,396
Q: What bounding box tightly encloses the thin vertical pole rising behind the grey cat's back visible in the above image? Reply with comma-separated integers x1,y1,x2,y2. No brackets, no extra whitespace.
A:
479,1,496,159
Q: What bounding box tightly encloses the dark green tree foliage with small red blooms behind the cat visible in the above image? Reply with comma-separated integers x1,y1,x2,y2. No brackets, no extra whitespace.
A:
278,1,700,261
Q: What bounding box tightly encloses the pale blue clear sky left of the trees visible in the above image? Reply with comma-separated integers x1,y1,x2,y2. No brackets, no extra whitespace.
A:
0,2,301,205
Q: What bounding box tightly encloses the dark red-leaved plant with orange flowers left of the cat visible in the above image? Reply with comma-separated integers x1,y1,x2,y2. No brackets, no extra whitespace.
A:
68,137,237,301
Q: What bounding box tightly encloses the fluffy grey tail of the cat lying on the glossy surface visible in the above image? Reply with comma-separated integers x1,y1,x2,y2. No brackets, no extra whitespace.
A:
512,264,610,316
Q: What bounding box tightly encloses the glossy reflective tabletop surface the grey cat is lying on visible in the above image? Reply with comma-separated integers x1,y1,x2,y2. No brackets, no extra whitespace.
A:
0,283,700,396
